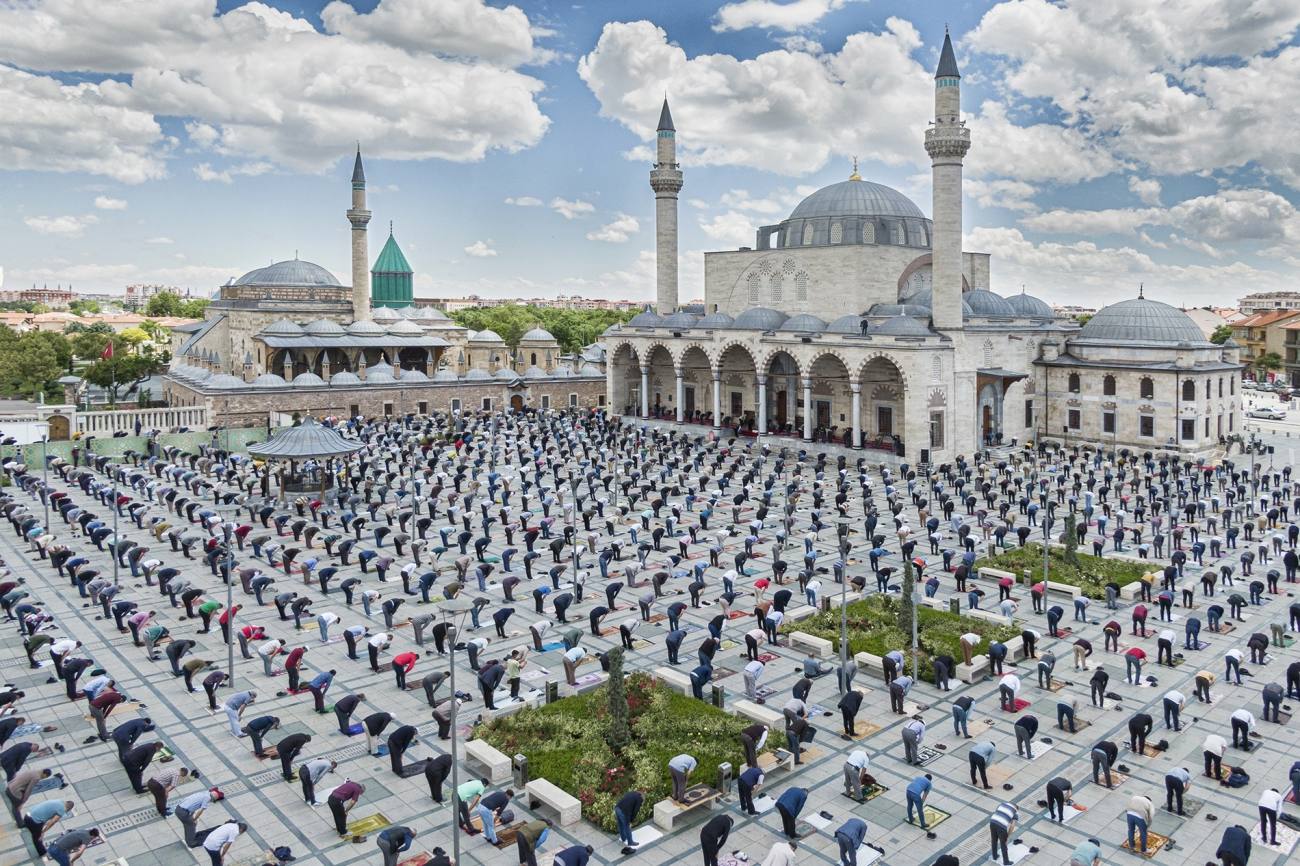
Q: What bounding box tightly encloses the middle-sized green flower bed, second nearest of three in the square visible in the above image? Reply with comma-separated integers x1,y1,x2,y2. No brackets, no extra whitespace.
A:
788,596,1021,683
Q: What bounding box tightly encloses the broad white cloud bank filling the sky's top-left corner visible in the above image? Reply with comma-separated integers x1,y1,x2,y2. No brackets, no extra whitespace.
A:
0,0,550,175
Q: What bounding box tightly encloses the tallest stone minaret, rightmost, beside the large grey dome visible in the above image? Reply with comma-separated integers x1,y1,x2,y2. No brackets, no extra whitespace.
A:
926,29,971,329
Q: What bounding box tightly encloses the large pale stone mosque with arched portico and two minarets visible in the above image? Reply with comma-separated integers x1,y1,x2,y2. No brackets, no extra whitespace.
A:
603,34,1242,463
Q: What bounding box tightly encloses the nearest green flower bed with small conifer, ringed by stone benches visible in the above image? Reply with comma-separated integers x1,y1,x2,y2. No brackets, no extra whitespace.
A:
477,674,751,832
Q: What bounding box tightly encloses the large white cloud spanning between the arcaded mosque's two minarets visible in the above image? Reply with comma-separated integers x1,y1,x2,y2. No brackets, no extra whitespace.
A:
579,18,935,176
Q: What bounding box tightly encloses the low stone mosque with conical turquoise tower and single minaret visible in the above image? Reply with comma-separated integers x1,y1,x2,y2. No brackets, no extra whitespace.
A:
164,150,605,425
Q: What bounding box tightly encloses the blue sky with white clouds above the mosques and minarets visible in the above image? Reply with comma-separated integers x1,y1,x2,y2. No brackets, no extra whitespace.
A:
0,0,1300,304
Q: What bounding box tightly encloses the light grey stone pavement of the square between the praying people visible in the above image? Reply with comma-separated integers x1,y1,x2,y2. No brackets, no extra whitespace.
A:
0,413,1300,866
